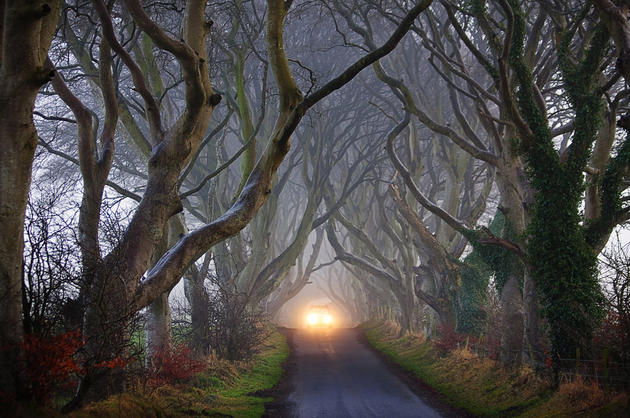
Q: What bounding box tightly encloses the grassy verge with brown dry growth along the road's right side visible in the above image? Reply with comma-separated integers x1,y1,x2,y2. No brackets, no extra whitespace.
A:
362,321,630,417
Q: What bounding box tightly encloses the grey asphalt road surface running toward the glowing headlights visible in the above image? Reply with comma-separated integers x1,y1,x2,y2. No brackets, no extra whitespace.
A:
282,329,466,418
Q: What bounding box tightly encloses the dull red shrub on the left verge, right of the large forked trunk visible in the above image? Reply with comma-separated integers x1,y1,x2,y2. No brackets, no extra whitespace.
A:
146,344,206,387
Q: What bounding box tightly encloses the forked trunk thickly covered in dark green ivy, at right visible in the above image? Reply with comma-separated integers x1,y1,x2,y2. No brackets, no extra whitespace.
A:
509,0,608,358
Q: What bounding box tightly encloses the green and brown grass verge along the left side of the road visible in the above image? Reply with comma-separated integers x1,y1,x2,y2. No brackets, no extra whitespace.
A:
70,330,289,418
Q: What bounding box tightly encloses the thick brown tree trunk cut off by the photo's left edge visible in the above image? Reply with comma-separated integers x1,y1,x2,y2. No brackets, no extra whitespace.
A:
0,0,61,398
